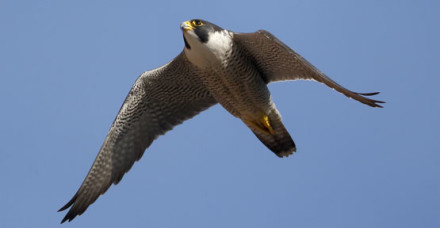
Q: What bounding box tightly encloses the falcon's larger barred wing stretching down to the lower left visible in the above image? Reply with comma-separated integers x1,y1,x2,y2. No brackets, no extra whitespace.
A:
60,52,217,223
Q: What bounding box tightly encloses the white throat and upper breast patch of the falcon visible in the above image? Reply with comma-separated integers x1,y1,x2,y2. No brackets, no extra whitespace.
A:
184,30,233,69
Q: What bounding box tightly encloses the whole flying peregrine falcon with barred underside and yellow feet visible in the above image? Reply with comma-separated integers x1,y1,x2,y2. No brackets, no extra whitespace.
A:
59,19,385,223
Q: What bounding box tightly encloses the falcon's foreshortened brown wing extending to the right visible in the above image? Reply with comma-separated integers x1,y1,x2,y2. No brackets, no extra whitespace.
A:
234,30,385,107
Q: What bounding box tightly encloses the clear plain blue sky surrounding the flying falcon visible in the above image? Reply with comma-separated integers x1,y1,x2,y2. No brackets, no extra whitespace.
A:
0,0,440,228
